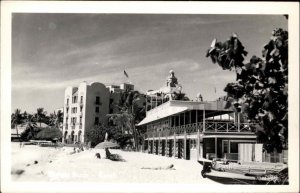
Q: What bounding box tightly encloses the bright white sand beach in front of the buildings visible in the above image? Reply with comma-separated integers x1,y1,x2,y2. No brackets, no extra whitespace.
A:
12,143,215,184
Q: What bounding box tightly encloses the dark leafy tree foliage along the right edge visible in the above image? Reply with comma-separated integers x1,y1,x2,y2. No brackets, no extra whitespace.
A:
207,28,288,152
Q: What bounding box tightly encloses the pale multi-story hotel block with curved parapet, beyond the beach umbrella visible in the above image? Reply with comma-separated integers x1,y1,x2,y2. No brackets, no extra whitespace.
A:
62,82,134,143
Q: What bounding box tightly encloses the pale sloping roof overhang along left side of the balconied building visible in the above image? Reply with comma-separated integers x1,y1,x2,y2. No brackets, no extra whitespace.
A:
138,106,188,126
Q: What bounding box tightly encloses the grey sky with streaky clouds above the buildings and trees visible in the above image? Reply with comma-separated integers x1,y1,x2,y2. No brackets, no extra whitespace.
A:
12,13,288,113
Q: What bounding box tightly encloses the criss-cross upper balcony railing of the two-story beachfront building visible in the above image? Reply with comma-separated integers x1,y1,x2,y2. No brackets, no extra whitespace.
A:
146,122,256,137
